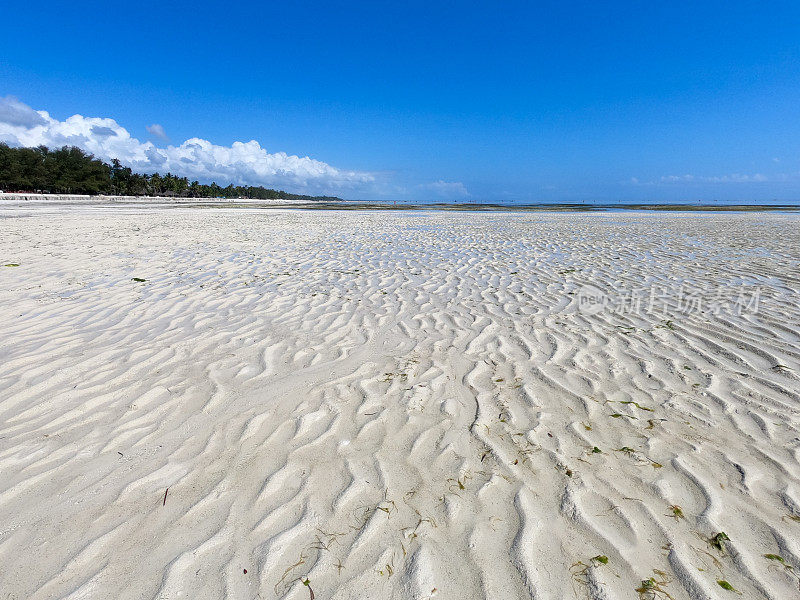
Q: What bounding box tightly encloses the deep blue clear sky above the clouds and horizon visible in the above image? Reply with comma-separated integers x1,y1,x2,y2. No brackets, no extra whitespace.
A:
0,1,800,201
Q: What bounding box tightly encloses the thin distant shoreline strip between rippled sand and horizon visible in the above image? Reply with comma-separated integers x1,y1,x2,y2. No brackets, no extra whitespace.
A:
0,192,800,212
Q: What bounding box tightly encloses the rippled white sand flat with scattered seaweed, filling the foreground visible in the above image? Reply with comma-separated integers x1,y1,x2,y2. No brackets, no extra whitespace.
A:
0,206,800,600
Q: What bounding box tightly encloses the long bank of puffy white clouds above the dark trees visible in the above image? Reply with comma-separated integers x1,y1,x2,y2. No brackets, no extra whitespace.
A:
0,96,375,193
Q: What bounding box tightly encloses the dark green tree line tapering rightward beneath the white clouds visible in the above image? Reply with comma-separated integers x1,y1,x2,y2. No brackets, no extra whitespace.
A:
0,143,339,200
